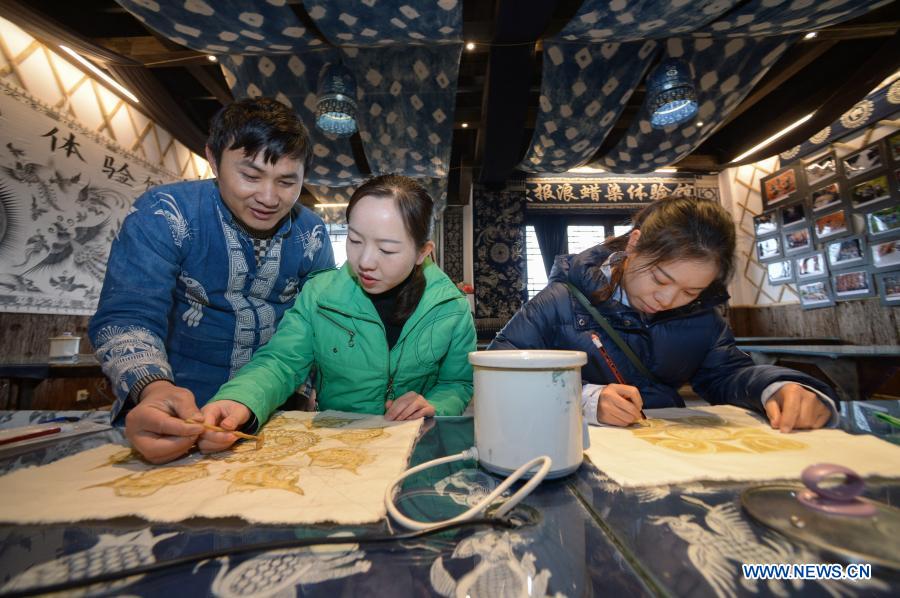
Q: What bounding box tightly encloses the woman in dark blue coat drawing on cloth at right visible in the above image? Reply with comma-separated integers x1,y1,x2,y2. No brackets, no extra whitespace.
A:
490,198,838,432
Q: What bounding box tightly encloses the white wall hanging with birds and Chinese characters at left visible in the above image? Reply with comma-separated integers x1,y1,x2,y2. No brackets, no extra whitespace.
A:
0,87,179,315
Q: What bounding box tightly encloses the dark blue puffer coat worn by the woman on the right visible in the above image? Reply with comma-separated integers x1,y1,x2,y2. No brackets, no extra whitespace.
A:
489,245,836,412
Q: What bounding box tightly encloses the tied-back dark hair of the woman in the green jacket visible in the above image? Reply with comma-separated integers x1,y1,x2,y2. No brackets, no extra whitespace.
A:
346,174,434,323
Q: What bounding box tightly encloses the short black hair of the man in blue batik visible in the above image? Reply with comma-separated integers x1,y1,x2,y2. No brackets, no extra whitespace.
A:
206,98,312,172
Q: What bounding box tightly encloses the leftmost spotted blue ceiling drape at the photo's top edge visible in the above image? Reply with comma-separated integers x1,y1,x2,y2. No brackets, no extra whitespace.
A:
116,0,322,54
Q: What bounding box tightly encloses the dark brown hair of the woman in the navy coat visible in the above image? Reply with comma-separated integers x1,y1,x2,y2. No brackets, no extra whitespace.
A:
592,197,735,302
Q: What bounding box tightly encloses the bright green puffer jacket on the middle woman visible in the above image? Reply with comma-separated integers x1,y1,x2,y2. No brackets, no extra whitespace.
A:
211,259,475,424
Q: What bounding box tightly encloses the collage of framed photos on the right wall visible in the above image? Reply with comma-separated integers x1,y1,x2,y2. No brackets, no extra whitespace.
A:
753,132,900,309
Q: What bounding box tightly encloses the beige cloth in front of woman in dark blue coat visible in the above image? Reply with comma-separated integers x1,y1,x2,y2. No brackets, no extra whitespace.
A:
585,406,900,487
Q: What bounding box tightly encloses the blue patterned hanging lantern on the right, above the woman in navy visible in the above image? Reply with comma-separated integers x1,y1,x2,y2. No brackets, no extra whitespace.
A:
647,58,697,129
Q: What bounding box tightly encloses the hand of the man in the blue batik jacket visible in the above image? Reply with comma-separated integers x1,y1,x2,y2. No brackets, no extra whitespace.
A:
125,380,203,464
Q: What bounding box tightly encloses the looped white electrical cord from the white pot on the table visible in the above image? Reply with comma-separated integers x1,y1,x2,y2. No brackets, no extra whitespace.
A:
384,446,553,530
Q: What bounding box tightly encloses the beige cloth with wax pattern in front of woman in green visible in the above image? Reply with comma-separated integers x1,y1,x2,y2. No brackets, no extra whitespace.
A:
0,411,422,524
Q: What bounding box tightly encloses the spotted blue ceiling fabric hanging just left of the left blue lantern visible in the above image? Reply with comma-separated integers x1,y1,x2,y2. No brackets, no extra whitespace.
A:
220,55,364,187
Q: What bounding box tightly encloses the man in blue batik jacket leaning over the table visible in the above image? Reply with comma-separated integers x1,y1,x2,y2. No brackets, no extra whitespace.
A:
89,98,334,462
